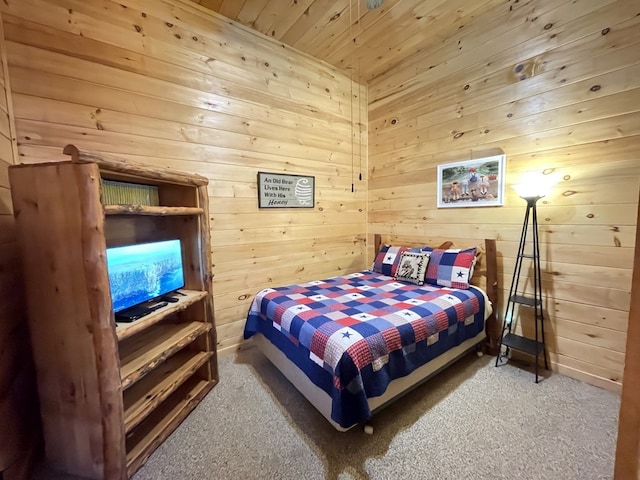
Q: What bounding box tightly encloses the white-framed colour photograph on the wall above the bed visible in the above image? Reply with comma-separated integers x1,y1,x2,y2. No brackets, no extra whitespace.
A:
438,155,505,208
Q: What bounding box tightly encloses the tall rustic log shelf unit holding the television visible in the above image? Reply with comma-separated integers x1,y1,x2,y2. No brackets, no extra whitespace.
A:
9,145,218,480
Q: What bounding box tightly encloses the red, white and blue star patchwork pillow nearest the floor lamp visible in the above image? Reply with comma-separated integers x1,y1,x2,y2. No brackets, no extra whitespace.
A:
425,247,476,289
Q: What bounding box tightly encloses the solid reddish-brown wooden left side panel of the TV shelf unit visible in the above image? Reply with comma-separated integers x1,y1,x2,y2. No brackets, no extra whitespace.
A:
9,163,126,479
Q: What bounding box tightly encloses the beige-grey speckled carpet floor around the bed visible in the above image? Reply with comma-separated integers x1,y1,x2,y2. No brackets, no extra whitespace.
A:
134,348,619,480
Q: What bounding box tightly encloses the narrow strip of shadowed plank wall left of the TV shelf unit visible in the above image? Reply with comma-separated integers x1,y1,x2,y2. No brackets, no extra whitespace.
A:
0,8,39,480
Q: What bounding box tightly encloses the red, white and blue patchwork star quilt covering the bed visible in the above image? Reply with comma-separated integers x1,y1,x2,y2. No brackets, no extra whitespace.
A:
244,271,485,428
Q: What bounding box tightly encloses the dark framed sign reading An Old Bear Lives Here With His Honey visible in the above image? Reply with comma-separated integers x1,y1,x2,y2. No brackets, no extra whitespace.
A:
258,172,315,208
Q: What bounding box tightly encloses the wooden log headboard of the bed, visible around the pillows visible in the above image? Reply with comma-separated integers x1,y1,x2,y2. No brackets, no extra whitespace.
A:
373,233,500,355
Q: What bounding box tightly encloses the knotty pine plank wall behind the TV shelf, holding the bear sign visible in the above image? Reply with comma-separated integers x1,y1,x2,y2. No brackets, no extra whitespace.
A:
1,0,367,362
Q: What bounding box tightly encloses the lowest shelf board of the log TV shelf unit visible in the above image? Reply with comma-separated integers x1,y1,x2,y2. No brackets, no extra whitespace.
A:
126,377,214,477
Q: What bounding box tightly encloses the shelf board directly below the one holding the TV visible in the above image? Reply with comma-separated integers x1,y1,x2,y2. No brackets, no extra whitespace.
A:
120,322,211,390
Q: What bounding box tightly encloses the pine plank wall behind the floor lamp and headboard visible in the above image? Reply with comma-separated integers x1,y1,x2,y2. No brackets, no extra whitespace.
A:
368,0,640,390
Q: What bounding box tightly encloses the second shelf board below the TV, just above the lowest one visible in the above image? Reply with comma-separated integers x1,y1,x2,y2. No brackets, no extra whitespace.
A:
124,349,213,433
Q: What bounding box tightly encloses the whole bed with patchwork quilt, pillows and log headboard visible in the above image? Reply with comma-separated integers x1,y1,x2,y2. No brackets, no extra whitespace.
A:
244,235,499,431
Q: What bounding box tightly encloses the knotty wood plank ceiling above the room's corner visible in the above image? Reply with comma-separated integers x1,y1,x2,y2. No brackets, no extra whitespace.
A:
192,0,506,82
